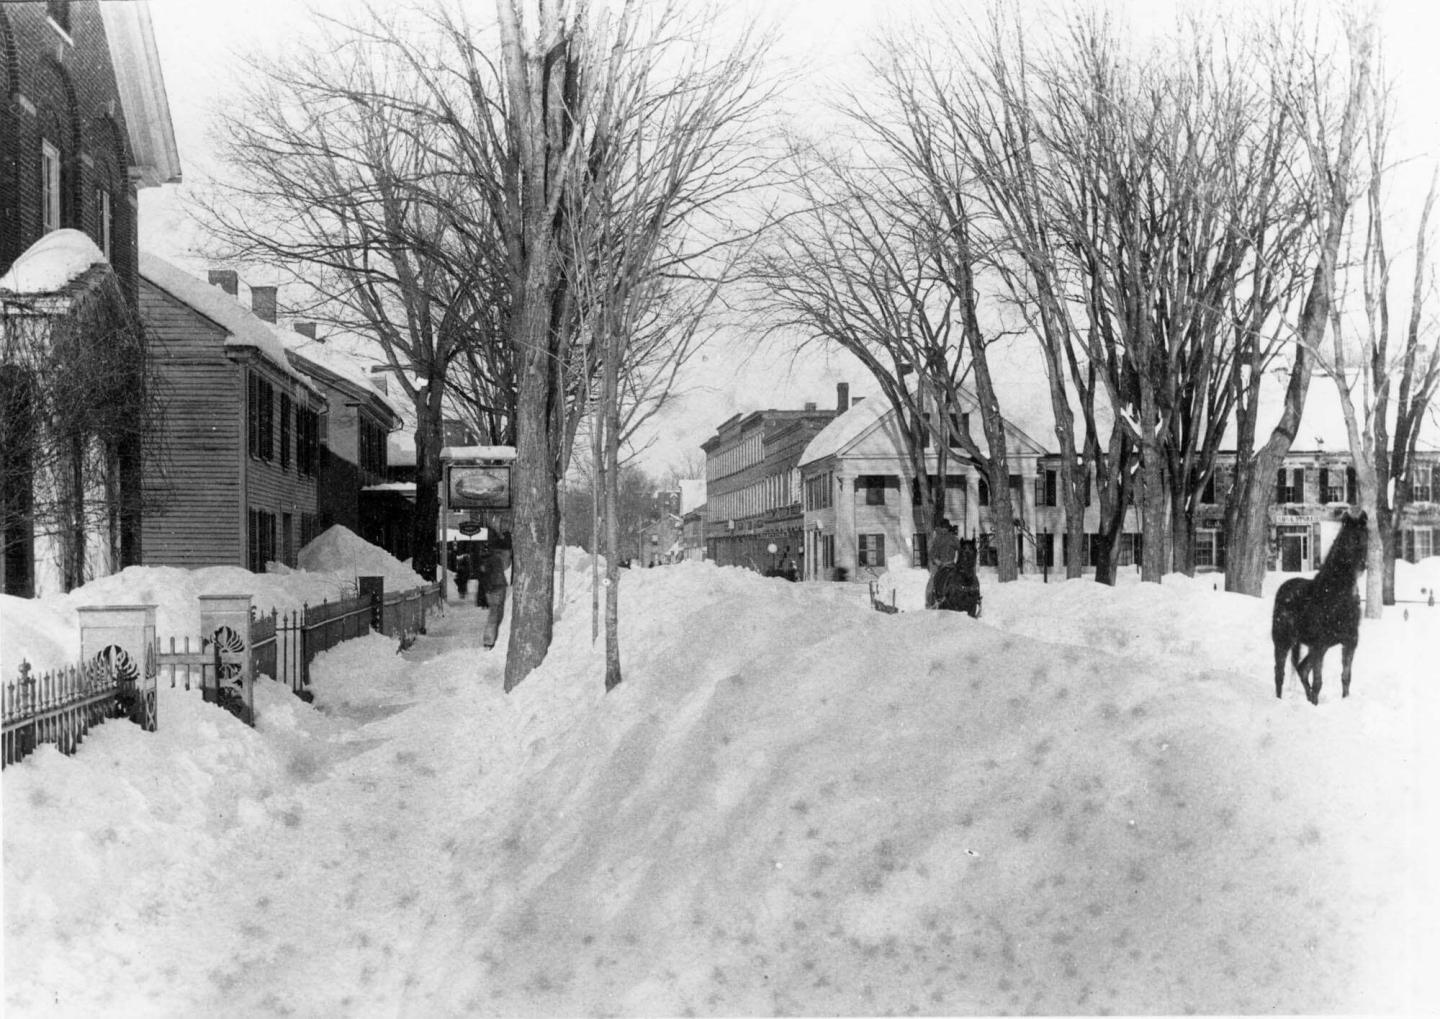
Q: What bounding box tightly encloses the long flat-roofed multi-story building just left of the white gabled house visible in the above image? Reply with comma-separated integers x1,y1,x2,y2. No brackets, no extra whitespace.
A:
701,383,850,573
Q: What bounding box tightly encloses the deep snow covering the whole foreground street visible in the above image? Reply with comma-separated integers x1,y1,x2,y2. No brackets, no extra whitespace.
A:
3,558,1440,1016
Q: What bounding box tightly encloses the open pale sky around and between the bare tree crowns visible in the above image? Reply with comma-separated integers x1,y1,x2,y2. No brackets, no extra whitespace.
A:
141,0,1440,474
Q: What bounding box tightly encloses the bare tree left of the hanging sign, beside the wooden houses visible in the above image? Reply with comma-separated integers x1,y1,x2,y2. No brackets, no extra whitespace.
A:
200,9,508,576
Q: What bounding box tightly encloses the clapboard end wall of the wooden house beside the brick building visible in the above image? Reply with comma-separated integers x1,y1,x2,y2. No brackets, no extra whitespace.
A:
140,282,245,567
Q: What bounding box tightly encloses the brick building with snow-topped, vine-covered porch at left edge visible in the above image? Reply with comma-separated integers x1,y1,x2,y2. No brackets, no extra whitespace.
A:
0,0,180,596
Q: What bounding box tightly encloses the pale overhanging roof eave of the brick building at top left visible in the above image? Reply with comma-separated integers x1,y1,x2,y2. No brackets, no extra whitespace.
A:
99,0,180,187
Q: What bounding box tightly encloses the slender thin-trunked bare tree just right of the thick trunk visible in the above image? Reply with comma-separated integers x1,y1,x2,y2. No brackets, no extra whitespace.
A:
563,3,768,689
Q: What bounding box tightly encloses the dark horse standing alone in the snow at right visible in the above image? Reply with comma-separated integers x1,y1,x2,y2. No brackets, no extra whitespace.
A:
1270,511,1369,704
